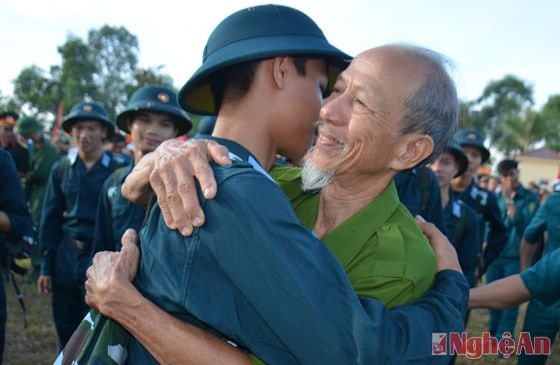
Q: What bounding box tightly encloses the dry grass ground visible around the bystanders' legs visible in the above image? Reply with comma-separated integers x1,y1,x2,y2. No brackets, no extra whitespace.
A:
4,278,560,365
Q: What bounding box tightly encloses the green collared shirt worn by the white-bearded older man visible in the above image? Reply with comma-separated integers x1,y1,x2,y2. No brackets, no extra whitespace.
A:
271,165,436,308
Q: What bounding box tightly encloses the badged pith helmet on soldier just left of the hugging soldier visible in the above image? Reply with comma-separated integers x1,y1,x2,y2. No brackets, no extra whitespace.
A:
117,85,192,136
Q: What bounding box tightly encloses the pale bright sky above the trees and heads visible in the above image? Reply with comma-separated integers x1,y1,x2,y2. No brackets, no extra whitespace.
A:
0,0,560,106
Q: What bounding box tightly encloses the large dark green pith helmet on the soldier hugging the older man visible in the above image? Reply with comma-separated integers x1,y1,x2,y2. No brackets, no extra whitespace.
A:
178,5,351,115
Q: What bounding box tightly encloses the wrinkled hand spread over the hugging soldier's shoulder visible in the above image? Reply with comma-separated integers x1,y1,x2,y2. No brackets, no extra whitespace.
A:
150,139,231,236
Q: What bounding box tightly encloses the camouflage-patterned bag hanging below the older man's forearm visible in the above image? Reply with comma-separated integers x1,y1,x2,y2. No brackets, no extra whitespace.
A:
53,309,130,365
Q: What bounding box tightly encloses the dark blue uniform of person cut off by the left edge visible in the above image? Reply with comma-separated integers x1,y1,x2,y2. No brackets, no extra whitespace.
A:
0,148,32,363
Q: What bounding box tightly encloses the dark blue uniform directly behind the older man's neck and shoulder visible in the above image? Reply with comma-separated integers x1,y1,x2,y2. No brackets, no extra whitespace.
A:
394,166,445,232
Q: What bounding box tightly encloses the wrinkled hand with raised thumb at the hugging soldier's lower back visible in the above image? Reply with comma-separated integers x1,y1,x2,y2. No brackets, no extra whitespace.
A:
85,229,140,316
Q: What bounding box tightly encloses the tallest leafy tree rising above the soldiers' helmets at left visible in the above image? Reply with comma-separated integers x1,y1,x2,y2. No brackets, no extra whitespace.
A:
88,25,139,116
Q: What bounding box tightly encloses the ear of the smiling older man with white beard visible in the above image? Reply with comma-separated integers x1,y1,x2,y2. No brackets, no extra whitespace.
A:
390,134,434,171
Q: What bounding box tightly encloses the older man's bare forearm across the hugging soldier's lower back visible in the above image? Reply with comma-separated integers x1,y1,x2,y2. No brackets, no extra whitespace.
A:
101,284,251,365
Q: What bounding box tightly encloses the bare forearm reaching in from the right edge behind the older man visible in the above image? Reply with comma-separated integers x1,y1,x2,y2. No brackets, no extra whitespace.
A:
469,275,531,309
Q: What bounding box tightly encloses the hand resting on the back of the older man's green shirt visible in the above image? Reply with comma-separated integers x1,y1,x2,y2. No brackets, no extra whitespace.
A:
416,215,463,273
